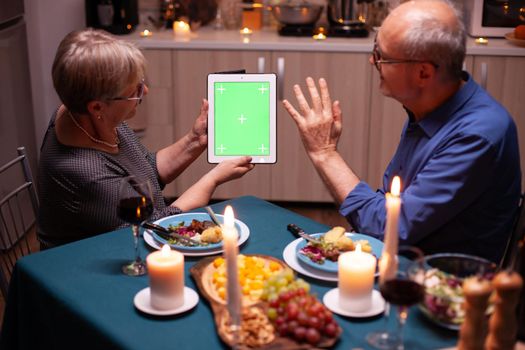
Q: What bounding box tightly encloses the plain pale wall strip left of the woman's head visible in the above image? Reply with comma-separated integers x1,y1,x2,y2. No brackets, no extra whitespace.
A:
24,0,86,152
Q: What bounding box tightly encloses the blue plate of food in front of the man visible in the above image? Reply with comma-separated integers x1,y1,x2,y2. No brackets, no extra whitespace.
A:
296,226,383,273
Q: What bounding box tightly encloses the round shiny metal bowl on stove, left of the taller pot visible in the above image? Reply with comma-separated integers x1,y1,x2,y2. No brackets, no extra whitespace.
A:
271,0,323,25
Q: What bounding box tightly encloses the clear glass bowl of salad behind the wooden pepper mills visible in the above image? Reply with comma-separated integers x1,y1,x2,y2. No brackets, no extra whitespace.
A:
419,253,497,330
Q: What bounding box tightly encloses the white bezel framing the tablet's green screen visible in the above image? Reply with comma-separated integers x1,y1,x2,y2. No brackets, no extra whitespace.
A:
207,73,277,164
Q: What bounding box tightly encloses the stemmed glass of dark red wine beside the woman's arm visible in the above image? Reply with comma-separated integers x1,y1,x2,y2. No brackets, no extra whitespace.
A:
117,176,153,276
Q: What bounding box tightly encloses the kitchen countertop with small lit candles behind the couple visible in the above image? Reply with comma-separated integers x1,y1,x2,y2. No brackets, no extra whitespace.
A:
121,27,525,56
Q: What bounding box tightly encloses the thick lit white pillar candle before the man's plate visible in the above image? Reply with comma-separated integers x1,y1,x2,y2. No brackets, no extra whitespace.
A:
338,244,377,312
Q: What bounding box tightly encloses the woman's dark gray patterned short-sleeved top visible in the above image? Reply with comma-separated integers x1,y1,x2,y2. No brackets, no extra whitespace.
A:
37,112,181,247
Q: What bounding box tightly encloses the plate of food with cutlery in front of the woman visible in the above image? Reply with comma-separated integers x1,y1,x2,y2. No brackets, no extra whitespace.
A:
144,213,250,255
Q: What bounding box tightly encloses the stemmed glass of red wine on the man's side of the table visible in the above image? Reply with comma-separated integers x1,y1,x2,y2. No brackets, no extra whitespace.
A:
367,246,425,349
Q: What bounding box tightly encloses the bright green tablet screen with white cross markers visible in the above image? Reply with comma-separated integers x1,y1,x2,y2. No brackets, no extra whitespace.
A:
214,82,270,156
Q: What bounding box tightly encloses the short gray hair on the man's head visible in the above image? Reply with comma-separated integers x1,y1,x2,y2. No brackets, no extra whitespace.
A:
400,0,467,80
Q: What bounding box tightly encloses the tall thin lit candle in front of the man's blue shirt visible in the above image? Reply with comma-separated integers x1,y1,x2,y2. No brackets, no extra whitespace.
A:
379,176,401,283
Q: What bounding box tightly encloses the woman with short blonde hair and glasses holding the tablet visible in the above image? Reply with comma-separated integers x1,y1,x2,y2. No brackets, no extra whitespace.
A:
38,29,253,247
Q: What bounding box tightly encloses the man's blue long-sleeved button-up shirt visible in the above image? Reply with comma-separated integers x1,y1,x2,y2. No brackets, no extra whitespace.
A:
340,73,521,262
